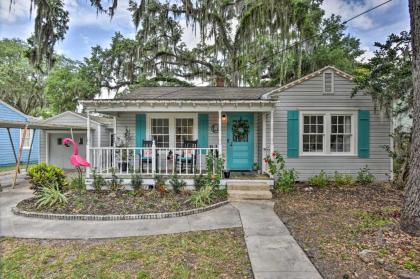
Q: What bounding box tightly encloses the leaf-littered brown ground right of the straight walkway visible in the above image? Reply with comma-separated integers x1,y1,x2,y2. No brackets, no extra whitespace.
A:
275,184,420,278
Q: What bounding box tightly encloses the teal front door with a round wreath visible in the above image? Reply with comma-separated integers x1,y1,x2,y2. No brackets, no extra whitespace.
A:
226,112,254,170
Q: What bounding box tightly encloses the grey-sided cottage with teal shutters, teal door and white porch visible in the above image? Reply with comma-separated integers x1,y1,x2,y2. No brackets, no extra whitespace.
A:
81,67,392,186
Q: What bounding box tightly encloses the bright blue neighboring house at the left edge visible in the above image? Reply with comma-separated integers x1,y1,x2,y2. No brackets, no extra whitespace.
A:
0,101,40,166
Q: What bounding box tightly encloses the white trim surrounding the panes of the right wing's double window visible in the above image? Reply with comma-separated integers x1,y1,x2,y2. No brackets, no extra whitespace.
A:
299,110,358,157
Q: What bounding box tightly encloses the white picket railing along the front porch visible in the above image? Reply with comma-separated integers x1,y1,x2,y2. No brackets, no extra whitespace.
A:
89,145,219,176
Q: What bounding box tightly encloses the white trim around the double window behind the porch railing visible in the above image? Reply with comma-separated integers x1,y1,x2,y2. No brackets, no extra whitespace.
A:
146,113,198,148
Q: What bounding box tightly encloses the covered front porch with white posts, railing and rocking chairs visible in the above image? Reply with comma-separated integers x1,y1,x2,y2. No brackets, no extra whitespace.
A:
83,100,274,183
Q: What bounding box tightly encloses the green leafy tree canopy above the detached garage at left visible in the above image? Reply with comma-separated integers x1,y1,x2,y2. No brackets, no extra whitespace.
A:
0,39,100,116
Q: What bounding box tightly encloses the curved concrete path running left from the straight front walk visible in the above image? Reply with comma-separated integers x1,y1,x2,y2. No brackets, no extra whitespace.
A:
0,187,241,239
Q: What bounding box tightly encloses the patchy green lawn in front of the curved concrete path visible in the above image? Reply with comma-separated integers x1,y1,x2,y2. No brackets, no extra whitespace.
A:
0,229,252,278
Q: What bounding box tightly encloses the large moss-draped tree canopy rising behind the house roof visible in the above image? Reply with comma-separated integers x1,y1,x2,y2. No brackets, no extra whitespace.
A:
13,0,363,90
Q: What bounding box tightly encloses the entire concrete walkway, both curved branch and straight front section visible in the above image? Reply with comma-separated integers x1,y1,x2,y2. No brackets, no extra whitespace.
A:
0,183,321,279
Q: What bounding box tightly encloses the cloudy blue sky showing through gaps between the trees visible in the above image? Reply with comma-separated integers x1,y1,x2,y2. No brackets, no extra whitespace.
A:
0,0,409,59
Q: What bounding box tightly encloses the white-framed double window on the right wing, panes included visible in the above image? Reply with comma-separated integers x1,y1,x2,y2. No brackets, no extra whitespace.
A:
300,112,356,155
